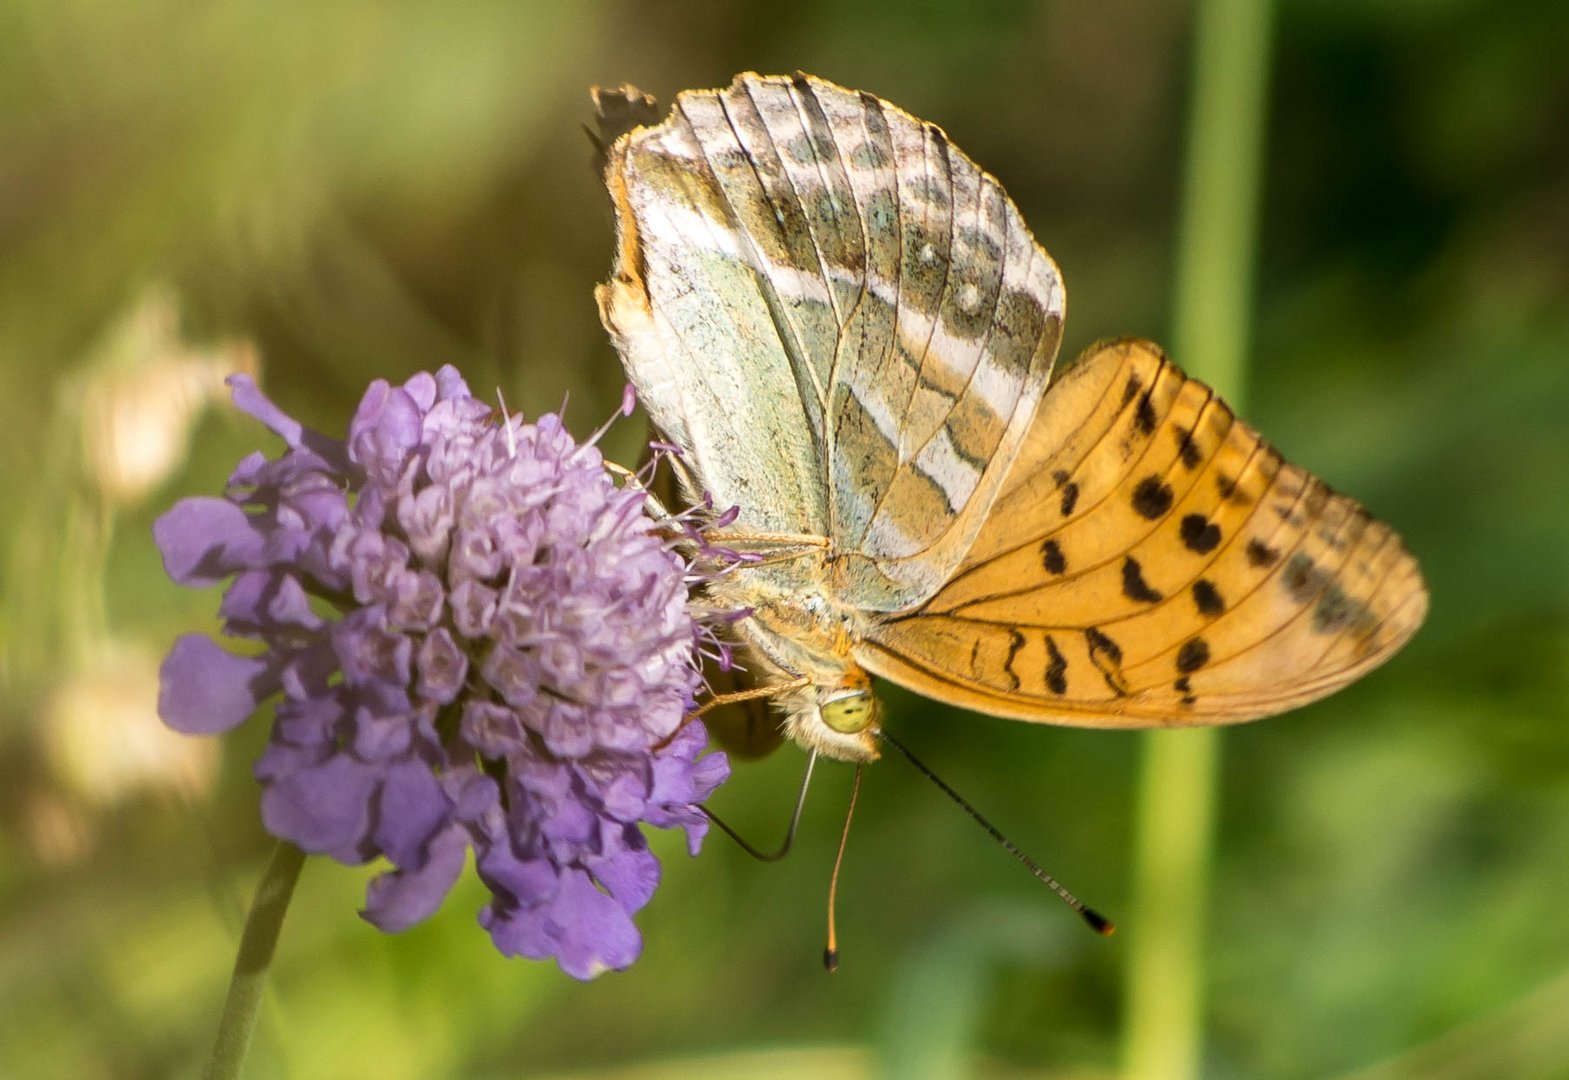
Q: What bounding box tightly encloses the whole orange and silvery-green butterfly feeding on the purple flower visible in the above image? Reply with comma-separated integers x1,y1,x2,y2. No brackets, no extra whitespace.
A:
598,72,1428,761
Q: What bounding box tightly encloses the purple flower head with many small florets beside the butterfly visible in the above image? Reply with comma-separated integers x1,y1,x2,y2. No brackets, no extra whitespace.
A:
154,367,730,978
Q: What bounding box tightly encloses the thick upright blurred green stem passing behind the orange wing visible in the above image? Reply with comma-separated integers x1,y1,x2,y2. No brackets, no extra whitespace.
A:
1123,0,1271,1080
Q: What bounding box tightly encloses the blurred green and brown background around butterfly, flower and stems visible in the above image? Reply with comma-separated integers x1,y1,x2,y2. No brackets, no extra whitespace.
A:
0,0,1569,1080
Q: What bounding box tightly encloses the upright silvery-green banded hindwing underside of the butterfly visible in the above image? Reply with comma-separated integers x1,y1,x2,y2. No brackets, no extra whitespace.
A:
601,74,1064,611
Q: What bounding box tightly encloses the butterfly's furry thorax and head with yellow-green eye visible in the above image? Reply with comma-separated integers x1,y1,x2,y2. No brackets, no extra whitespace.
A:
709,551,879,761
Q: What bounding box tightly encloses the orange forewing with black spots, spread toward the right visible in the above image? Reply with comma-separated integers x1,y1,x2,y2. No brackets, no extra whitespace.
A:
857,342,1426,727
